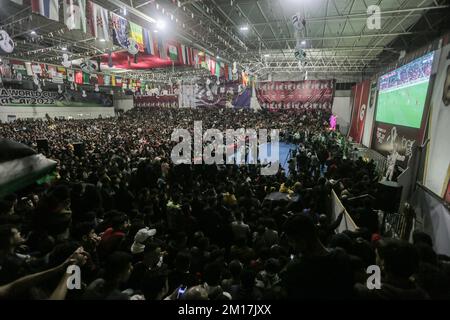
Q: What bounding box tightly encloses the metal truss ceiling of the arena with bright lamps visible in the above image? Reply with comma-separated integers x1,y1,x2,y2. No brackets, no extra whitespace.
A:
0,0,450,80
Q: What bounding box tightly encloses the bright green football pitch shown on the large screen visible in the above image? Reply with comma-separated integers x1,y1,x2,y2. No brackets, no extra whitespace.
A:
376,81,429,128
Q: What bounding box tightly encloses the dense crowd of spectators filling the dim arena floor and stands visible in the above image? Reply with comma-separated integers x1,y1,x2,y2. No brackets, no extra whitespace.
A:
0,108,450,300
